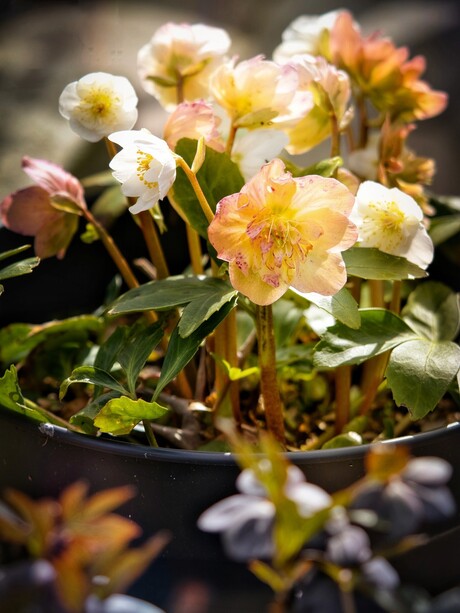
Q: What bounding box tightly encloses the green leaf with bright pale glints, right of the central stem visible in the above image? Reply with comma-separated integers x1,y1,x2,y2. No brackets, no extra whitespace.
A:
313,309,418,368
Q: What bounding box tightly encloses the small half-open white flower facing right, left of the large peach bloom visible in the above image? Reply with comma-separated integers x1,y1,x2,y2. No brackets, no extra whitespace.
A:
109,128,176,213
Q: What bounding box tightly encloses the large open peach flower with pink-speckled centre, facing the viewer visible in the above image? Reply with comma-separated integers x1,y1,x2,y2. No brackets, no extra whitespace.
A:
208,159,357,305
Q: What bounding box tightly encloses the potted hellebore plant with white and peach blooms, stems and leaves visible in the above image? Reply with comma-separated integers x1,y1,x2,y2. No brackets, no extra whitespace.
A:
0,11,460,450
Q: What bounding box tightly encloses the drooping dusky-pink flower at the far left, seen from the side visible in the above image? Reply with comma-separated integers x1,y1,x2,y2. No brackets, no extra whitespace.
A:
0,157,86,259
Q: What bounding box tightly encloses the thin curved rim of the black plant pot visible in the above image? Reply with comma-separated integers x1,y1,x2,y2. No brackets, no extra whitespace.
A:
0,407,460,466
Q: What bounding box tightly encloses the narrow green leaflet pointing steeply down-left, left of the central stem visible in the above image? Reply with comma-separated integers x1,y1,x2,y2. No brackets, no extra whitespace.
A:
153,297,236,400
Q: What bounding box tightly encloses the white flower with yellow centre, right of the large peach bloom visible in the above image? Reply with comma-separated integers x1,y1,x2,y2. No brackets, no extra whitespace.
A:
350,181,434,269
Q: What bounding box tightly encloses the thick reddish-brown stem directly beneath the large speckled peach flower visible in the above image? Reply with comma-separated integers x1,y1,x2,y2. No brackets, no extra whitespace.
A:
256,305,285,444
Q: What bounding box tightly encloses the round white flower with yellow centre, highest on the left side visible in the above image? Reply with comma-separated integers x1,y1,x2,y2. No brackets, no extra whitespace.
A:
59,72,137,143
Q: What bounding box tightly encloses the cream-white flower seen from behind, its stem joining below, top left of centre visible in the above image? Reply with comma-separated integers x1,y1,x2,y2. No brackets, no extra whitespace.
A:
137,23,231,111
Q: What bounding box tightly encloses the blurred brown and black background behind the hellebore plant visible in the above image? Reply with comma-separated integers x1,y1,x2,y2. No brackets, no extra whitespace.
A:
0,0,460,325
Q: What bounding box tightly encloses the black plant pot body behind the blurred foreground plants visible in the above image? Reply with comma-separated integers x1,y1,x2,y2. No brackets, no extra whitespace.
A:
0,408,460,613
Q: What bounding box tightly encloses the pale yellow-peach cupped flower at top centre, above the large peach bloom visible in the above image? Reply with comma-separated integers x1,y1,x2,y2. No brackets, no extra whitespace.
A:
211,55,312,130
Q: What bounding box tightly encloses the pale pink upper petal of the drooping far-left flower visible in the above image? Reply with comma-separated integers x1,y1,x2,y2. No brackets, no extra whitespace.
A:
22,156,86,208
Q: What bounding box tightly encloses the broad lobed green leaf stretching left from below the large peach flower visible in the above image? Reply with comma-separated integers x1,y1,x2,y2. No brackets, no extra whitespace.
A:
109,275,238,338
